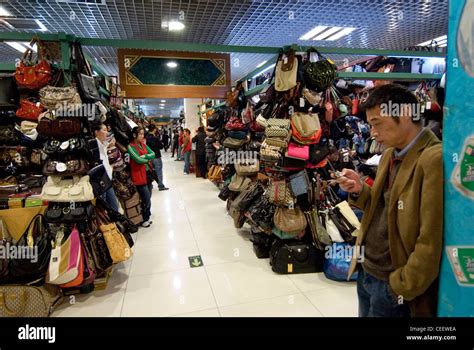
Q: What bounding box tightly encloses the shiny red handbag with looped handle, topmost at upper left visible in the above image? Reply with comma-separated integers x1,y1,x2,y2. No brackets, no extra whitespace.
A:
15,38,52,90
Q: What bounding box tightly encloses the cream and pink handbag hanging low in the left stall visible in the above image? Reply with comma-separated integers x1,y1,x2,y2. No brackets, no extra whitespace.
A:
46,227,84,285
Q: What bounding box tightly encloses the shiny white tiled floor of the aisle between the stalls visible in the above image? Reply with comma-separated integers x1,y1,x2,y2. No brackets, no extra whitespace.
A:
53,153,357,317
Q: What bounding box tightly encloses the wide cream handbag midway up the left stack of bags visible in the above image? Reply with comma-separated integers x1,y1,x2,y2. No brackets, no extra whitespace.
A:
41,175,94,202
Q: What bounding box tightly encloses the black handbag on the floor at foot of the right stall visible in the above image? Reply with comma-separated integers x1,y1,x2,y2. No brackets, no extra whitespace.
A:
270,239,324,274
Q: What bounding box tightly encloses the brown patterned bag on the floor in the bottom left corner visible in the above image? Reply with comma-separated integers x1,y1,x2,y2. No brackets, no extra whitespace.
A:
0,284,63,318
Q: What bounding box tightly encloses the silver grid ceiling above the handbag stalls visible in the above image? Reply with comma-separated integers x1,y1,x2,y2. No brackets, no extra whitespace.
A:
0,0,448,113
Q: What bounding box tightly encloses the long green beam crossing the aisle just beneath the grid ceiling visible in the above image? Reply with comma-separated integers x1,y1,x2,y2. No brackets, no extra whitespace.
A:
0,32,446,57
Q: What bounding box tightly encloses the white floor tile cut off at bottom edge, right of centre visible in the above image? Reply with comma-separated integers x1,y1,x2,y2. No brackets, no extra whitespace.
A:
219,294,322,317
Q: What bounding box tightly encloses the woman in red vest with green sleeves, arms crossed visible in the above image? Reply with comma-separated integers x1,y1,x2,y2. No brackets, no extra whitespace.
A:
128,126,155,227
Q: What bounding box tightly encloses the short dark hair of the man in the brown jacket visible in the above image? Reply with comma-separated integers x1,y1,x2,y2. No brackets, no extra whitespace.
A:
361,84,421,123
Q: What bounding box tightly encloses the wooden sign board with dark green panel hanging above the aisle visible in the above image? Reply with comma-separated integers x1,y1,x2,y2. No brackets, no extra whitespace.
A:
118,49,231,98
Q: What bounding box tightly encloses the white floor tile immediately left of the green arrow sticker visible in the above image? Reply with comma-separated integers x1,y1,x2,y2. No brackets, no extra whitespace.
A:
130,241,199,276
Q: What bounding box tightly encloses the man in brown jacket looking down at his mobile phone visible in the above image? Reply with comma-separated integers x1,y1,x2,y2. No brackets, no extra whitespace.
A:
335,84,443,317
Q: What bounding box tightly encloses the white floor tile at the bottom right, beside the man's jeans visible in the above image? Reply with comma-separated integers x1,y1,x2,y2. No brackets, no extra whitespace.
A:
304,283,358,317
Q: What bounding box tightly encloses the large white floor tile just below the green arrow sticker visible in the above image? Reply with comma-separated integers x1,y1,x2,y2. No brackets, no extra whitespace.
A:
122,267,216,317
